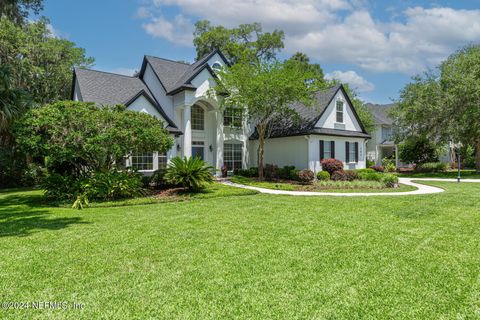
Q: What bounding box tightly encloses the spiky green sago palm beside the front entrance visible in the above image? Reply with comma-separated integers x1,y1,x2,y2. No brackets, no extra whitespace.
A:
165,157,215,191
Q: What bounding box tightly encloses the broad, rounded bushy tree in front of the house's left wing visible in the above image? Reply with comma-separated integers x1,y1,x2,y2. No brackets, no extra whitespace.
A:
14,101,173,177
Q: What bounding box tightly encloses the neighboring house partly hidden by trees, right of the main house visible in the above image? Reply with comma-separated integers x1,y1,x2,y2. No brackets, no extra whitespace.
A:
367,103,455,168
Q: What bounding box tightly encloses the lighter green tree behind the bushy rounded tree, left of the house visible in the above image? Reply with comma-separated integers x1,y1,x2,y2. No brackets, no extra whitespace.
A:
0,18,93,105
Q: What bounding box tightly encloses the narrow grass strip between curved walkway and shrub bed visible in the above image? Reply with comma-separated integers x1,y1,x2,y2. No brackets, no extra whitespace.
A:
230,176,417,193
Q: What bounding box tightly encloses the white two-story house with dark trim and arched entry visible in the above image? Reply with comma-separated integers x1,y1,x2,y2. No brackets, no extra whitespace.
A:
72,50,370,174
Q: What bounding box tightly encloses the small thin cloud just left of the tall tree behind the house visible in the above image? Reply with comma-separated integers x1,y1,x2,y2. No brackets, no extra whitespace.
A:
142,14,193,46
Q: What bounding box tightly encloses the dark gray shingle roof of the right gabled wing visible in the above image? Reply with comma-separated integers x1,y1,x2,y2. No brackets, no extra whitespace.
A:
250,84,370,139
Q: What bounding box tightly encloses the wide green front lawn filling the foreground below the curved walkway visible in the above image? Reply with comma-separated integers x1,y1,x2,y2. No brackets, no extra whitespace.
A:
0,182,480,319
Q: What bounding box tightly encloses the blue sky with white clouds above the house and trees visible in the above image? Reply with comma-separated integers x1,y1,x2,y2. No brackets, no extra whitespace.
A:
42,0,480,104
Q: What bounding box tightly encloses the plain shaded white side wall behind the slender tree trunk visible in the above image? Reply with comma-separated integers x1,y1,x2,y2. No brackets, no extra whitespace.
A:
248,136,308,169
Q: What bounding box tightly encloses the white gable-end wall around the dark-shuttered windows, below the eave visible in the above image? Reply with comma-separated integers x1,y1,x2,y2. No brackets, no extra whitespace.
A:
308,135,366,173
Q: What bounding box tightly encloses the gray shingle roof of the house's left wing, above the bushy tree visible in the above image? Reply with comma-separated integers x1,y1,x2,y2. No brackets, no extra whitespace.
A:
74,68,181,133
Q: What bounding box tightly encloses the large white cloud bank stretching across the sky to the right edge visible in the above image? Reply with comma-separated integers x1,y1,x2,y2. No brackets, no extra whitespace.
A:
137,0,480,74
